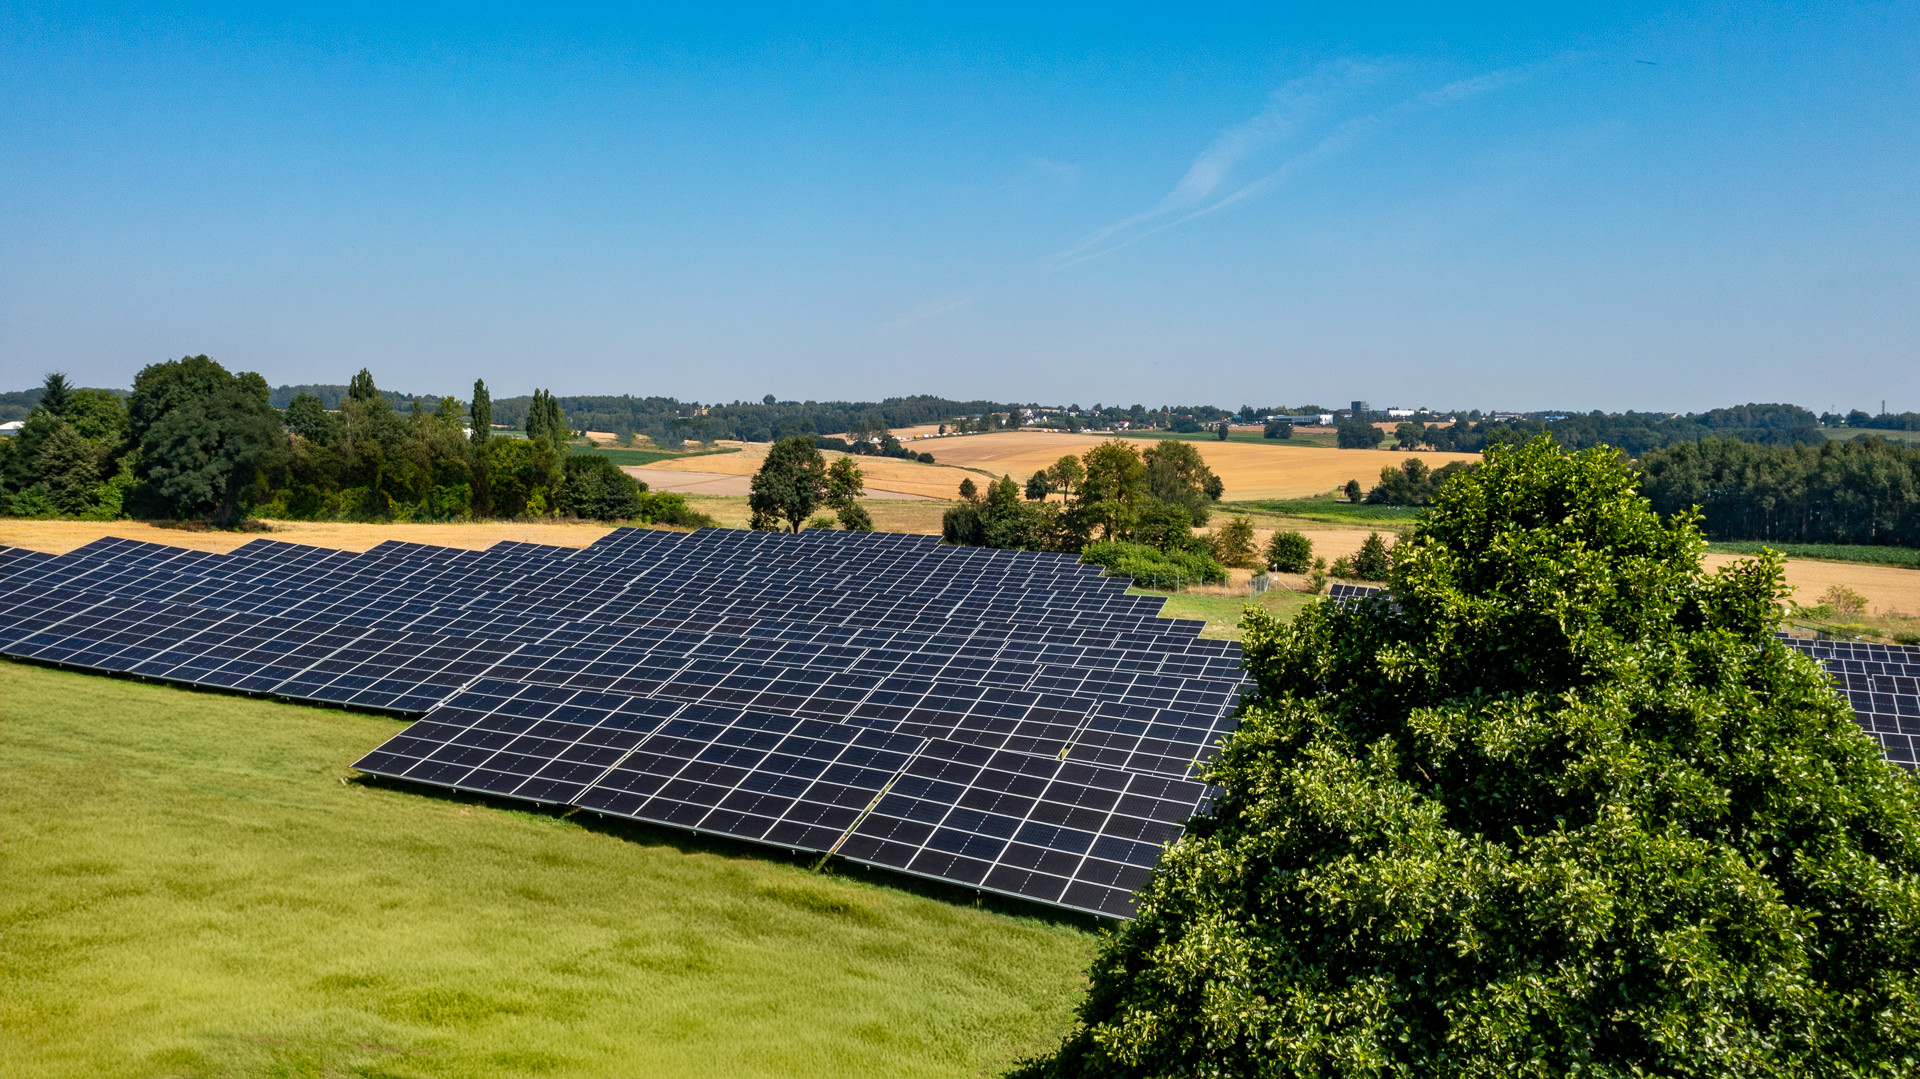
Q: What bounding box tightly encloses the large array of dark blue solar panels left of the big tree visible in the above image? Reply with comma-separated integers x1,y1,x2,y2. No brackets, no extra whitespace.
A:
0,530,1242,918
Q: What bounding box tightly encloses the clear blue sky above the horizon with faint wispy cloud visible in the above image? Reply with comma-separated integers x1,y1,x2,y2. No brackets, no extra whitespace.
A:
0,2,1920,411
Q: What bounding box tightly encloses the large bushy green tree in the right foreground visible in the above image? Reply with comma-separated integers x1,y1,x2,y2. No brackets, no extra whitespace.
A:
1023,440,1920,1079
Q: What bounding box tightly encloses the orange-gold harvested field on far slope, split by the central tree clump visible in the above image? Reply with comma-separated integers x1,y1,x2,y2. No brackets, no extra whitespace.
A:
914,430,1480,501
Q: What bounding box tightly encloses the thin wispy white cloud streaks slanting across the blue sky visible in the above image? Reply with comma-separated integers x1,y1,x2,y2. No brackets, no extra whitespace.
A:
1046,63,1534,267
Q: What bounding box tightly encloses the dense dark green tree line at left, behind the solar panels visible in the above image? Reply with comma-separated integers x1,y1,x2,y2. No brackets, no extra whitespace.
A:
0,355,705,526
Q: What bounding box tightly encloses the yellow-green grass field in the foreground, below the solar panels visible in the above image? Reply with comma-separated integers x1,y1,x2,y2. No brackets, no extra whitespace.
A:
0,662,1098,1077
